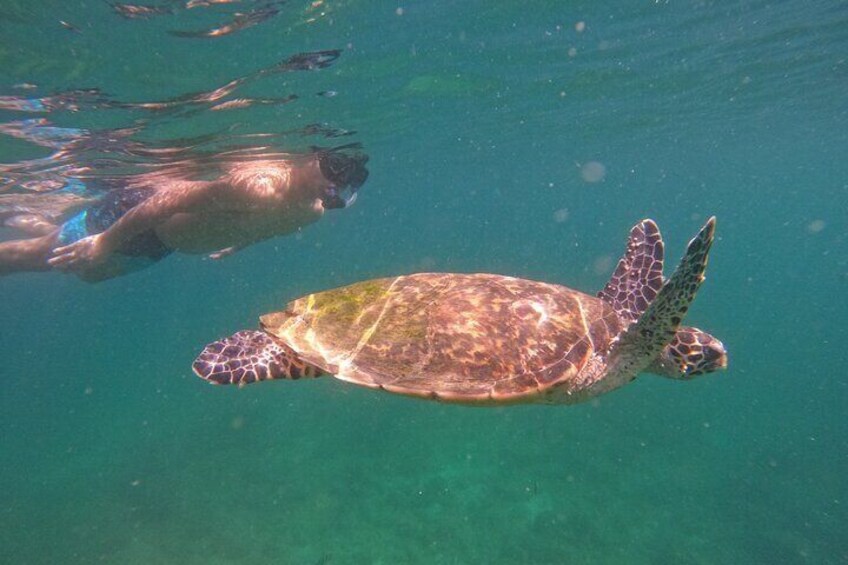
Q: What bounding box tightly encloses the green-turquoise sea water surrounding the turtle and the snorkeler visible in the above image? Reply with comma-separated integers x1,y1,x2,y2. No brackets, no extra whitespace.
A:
0,0,848,565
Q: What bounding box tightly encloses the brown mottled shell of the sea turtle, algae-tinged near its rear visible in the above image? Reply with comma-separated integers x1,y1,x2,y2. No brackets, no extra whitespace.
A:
262,273,621,403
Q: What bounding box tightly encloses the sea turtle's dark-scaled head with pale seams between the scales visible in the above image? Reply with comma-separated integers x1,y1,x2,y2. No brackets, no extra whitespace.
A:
648,326,727,380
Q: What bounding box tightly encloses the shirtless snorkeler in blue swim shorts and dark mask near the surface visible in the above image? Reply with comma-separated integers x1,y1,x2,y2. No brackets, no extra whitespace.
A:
0,151,368,282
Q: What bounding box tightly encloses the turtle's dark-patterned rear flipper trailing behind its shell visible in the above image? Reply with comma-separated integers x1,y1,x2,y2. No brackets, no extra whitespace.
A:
192,330,321,385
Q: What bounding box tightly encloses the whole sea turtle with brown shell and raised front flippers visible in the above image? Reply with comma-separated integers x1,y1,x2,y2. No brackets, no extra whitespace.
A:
193,218,727,405
